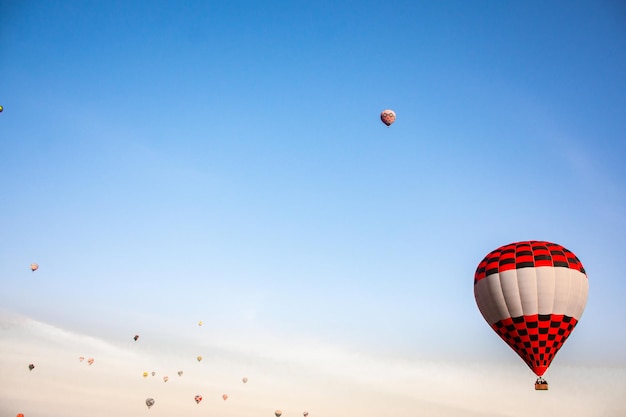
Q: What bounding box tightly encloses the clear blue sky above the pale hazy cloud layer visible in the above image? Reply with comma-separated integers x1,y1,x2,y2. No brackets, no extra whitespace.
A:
0,1,626,417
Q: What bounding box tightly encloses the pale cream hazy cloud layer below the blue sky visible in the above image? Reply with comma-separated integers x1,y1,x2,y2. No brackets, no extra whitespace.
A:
0,313,626,417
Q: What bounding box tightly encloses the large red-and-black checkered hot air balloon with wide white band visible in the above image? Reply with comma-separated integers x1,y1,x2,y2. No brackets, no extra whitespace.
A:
474,241,589,389
